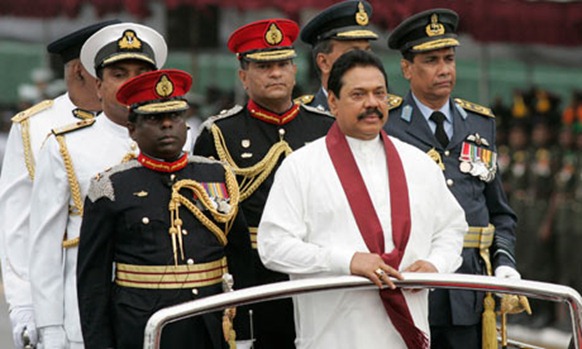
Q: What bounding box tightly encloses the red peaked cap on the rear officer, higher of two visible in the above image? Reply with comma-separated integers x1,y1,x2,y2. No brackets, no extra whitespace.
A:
227,18,299,62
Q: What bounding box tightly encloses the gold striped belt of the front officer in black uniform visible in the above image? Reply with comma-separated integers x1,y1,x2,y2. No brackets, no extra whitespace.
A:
115,257,228,289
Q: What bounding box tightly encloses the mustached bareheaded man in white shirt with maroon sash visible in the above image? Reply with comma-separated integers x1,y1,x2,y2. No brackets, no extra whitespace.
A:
258,50,467,349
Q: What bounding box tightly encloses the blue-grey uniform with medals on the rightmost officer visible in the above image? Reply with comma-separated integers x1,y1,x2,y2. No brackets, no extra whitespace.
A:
385,93,516,326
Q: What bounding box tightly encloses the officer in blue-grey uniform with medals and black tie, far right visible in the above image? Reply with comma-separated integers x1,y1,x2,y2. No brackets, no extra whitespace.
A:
385,9,520,348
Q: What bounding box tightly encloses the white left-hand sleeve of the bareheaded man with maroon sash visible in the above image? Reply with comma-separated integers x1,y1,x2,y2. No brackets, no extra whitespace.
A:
257,154,356,275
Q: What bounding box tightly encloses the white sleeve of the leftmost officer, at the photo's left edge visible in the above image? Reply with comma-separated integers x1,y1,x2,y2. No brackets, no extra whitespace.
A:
0,124,32,309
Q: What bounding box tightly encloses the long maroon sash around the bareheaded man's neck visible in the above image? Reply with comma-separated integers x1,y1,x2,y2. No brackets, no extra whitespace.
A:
325,122,429,349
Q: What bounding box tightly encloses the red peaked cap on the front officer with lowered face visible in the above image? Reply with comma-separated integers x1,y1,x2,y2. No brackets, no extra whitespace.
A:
117,69,192,113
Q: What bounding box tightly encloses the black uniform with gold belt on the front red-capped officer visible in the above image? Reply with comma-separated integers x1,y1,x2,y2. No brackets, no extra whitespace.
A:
78,155,251,349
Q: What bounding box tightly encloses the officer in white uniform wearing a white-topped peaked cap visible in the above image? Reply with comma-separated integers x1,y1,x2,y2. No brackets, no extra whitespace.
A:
29,23,167,348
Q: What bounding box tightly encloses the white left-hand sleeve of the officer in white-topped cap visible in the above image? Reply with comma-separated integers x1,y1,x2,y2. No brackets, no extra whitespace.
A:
29,137,70,327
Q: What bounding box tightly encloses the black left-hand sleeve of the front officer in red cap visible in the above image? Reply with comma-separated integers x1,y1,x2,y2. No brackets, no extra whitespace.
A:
77,190,116,349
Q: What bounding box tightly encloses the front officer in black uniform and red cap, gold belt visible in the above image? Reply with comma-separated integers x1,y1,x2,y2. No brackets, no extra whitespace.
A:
77,69,252,349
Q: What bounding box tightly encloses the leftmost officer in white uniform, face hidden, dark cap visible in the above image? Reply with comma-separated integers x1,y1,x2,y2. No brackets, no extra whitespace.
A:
0,20,119,348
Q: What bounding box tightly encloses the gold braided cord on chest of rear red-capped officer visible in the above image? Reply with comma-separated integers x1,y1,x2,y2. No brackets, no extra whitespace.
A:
211,125,293,201
